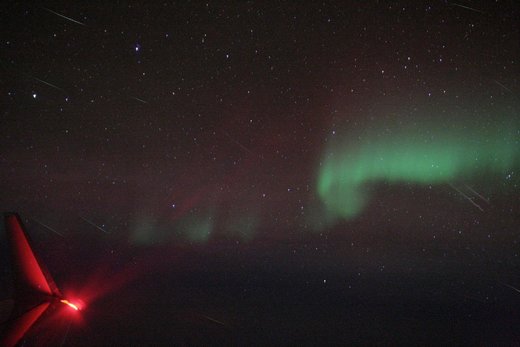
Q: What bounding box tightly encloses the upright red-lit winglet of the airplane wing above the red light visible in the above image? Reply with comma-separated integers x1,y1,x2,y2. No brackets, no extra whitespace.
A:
4,213,61,296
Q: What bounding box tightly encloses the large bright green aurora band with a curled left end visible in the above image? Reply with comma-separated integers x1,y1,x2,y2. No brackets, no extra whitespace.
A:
317,115,520,220
